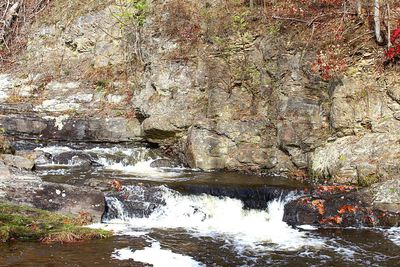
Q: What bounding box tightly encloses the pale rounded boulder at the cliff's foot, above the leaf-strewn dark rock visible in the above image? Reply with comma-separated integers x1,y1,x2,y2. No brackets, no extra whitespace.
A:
311,133,400,186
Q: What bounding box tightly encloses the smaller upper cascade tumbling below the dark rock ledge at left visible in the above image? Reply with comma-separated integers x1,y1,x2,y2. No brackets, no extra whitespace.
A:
35,146,191,180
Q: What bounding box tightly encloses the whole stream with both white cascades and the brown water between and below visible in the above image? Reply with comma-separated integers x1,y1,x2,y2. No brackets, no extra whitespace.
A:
10,145,400,267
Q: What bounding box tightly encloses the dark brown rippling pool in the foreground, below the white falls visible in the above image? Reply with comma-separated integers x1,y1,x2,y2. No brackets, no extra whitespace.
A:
0,229,400,267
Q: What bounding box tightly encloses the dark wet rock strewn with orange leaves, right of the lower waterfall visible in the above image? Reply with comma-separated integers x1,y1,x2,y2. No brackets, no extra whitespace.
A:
283,186,400,227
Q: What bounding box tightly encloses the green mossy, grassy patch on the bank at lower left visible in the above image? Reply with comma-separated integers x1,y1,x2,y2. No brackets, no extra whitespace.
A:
0,203,111,243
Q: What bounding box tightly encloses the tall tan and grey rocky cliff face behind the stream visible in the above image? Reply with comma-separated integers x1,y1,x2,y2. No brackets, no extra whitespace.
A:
0,0,400,188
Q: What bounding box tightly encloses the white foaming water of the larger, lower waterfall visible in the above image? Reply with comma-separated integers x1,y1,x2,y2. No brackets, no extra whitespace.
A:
93,187,323,251
